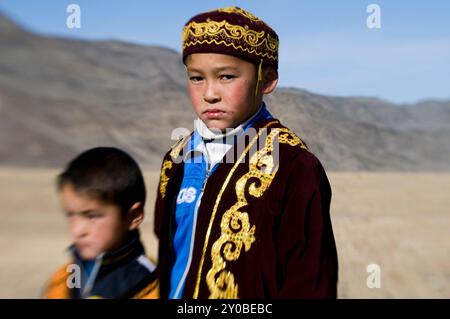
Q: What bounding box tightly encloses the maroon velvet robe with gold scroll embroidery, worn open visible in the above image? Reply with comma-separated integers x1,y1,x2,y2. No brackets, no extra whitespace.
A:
155,119,338,299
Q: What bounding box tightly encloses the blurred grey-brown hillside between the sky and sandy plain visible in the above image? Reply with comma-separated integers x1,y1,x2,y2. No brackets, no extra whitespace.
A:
0,16,450,170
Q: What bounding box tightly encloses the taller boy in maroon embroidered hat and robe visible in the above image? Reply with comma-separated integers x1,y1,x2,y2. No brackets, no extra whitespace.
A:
155,7,338,298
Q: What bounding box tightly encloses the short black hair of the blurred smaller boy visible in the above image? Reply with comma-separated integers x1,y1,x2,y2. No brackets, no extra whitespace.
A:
57,147,146,215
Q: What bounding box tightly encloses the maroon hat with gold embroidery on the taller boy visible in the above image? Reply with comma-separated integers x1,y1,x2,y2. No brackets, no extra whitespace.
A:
182,7,278,70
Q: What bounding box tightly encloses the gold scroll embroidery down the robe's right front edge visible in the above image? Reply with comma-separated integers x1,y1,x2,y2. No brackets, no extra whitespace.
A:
200,128,306,299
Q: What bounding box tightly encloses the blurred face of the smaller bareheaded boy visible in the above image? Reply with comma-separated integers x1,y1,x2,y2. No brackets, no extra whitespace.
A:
59,183,130,260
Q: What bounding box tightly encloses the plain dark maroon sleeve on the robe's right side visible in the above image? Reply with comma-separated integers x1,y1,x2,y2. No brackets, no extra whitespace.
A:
276,150,338,299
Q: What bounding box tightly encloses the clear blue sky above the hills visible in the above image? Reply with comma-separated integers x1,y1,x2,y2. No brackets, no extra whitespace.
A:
0,0,450,103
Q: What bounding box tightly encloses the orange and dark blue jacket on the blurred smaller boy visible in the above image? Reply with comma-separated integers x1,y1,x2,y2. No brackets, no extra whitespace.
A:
43,230,158,299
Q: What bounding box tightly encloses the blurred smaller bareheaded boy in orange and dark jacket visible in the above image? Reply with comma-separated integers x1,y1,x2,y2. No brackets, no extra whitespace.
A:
43,147,157,299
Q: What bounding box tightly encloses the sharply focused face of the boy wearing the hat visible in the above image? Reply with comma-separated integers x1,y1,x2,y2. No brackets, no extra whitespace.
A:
186,53,262,131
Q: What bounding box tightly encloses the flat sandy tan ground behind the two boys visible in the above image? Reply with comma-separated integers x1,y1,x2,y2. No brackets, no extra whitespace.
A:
0,167,450,298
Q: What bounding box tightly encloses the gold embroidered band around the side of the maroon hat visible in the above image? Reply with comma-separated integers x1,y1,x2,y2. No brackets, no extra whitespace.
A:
182,19,278,61
